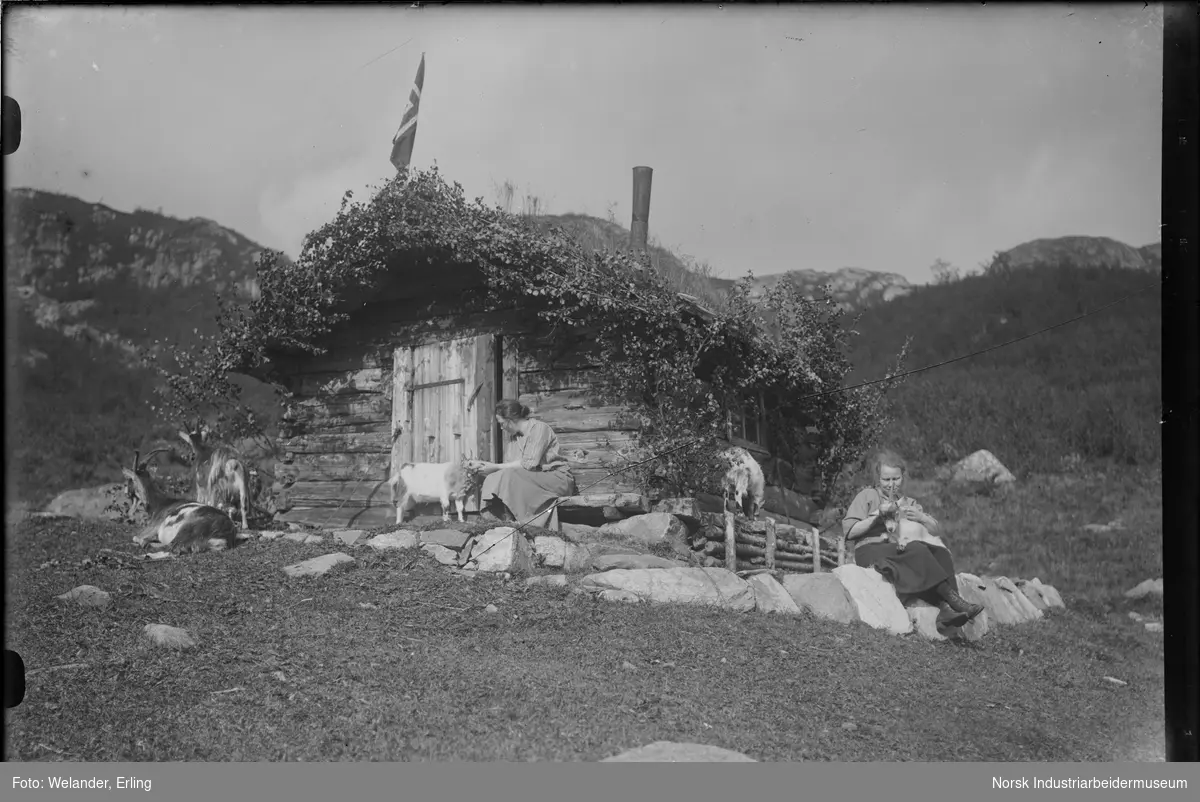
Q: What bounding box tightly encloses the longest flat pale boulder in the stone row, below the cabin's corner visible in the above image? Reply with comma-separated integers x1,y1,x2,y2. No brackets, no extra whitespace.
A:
580,568,755,612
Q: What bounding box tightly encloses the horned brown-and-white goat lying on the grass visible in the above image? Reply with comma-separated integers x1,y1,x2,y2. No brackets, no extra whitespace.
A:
121,448,239,553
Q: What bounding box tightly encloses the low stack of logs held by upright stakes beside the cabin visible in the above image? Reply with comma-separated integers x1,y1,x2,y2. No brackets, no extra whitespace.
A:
690,513,844,573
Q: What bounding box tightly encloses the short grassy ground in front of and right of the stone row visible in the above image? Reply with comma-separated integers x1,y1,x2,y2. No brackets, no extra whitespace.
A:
7,467,1163,761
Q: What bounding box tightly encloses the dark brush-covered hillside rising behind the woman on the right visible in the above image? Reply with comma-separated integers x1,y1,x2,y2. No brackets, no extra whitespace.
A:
851,267,1162,472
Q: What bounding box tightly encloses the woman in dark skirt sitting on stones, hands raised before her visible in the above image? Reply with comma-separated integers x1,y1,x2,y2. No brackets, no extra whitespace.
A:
841,451,983,627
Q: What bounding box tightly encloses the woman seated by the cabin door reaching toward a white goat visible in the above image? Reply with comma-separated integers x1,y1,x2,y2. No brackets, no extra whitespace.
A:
468,399,575,529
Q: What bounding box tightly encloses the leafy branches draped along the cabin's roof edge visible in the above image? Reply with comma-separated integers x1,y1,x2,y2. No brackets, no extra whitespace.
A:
147,168,902,492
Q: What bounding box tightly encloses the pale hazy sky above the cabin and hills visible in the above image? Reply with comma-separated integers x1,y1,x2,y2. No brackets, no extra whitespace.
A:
2,2,1163,282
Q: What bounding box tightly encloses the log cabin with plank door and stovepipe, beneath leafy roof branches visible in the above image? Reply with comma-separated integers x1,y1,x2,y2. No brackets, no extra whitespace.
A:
247,167,814,528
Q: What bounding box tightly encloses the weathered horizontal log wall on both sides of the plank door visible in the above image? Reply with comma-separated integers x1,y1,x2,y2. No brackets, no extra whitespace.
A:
264,294,825,527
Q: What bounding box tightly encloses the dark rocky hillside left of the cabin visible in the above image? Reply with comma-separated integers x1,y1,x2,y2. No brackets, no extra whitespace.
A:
5,190,280,504
